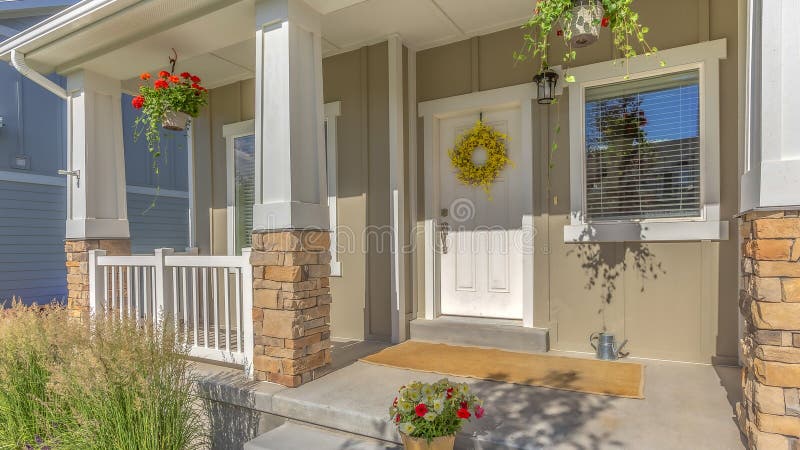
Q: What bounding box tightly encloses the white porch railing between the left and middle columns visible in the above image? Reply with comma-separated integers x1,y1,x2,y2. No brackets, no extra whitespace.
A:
89,248,253,372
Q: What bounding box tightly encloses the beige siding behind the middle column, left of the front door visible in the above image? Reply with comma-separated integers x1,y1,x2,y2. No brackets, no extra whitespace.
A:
193,42,391,340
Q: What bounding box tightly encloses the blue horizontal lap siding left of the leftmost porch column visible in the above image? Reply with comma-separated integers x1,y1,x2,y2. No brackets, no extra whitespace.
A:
0,181,67,303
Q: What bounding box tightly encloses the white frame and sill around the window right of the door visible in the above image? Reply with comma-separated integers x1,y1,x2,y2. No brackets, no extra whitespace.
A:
564,39,729,242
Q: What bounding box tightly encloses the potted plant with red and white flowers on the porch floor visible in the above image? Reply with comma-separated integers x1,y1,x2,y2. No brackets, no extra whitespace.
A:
389,378,484,450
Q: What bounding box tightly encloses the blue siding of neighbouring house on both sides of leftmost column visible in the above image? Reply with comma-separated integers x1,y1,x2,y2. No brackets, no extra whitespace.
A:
0,1,189,303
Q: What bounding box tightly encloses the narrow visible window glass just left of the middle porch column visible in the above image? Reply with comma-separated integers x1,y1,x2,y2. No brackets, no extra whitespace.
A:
233,134,256,254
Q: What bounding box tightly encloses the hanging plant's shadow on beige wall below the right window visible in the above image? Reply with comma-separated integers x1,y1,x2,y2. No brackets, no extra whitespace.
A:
567,224,667,331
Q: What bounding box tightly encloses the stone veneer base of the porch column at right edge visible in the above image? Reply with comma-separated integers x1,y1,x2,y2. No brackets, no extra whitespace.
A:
736,211,800,450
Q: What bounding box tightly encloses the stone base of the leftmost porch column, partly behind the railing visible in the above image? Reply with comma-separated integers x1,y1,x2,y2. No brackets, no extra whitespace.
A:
64,239,131,319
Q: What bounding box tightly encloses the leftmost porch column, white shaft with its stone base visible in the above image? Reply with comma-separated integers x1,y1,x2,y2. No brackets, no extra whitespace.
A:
64,71,131,319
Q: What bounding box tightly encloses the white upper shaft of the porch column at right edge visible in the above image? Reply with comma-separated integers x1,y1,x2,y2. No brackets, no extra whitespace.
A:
740,0,800,211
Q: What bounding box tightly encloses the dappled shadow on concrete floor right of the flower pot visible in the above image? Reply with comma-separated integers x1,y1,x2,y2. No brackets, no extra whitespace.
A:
456,372,625,450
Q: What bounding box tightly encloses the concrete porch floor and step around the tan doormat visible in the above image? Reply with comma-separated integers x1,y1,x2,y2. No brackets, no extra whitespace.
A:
197,342,744,450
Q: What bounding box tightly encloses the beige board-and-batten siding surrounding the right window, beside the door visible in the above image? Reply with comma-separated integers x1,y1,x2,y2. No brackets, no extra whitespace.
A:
417,0,739,363
